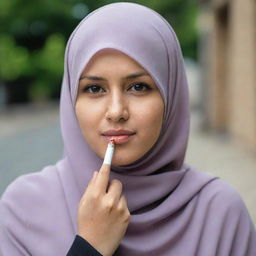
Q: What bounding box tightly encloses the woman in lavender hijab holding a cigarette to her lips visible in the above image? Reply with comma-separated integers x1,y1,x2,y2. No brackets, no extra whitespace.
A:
0,3,256,256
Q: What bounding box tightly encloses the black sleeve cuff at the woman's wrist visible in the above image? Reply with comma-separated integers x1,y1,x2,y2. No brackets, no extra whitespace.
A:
66,235,103,256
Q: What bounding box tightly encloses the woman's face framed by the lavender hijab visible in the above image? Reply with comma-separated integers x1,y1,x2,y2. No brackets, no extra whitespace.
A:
75,49,164,165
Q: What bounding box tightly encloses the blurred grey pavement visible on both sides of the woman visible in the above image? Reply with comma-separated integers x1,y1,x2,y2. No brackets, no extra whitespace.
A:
0,103,256,224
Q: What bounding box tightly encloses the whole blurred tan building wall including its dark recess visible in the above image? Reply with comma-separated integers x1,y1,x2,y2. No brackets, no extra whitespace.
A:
201,0,256,152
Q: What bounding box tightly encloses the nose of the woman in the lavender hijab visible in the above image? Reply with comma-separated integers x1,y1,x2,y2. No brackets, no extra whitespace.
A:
106,92,129,122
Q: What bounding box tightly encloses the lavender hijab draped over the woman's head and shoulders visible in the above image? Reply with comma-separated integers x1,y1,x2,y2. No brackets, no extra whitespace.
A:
0,3,256,256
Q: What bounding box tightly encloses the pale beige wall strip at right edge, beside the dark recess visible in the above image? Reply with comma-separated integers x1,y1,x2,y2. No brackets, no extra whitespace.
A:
228,0,256,149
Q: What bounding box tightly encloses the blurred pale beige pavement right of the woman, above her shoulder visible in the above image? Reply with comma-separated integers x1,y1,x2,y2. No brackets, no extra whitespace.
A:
186,111,256,225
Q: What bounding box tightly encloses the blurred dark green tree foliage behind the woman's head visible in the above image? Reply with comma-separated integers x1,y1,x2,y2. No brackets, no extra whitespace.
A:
0,0,197,102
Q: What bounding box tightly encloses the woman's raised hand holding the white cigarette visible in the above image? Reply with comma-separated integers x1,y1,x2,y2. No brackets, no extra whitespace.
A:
77,164,130,256
